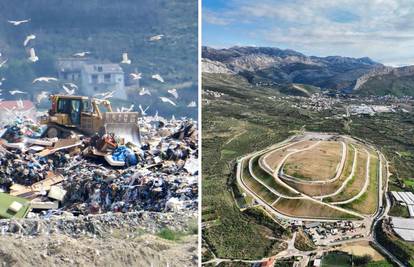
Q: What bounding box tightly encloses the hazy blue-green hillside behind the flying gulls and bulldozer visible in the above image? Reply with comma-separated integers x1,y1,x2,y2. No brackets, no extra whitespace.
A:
0,0,198,115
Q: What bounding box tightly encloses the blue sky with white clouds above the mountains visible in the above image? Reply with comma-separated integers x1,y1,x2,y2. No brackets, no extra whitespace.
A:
203,0,414,66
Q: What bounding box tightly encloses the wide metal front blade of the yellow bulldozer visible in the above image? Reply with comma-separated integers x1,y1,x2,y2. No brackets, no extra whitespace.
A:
104,112,140,144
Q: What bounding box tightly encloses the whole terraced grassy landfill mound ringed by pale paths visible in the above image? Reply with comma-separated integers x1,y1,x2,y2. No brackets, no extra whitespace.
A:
239,135,383,220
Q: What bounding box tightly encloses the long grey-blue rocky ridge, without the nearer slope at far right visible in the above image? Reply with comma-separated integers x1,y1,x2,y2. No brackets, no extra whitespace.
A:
202,46,384,90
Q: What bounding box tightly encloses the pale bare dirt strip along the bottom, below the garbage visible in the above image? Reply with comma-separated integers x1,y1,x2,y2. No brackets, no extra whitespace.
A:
0,234,197,267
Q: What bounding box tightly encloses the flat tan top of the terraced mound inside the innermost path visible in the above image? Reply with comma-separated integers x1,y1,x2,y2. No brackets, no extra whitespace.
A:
284,141,342,180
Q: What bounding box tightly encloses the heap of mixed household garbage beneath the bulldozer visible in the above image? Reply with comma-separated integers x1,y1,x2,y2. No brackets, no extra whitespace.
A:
0,116,198,218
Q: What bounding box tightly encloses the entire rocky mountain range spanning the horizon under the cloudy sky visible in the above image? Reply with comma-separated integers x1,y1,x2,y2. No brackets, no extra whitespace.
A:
202,46,414,96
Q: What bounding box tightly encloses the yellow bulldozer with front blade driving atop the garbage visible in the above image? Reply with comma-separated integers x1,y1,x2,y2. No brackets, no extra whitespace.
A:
41,95,140,144
